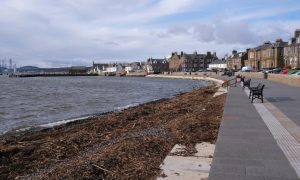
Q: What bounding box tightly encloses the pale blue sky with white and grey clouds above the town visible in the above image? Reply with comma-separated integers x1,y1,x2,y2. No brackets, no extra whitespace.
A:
0,0,300,68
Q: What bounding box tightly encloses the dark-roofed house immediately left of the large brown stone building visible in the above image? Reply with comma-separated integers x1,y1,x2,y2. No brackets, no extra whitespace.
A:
146,57,169,74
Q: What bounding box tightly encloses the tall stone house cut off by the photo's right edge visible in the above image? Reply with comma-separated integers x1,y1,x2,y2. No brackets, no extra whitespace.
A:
284,29,300,69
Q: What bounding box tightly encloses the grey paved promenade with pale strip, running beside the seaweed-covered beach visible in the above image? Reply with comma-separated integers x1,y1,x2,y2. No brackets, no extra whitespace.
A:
209,79,300,180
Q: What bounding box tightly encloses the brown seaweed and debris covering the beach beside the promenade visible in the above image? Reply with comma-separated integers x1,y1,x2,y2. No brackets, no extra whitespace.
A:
0,86,226,179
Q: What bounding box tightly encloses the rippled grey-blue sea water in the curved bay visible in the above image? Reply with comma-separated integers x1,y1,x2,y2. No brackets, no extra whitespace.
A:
0,76,209,134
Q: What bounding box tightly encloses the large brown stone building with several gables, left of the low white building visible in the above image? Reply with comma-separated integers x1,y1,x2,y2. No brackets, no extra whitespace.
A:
169,51,218,72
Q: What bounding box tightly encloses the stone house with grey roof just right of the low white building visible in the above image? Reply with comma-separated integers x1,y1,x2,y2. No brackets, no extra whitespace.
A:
227,50,248,70
